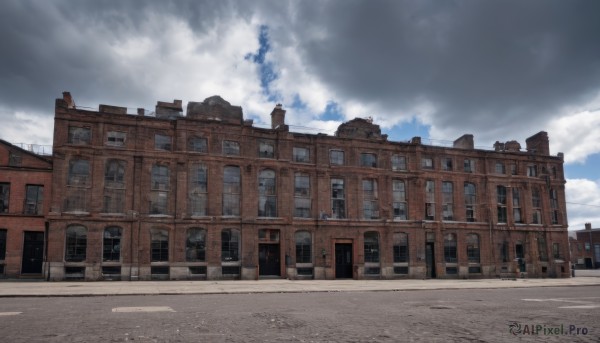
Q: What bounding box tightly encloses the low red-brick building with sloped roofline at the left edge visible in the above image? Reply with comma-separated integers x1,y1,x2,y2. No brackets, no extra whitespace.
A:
0,139,52,278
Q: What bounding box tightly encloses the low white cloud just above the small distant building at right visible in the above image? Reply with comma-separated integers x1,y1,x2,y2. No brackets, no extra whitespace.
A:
566,179,600,230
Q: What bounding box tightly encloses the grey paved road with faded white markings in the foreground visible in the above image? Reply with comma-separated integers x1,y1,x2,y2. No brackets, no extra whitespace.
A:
0,286,600,342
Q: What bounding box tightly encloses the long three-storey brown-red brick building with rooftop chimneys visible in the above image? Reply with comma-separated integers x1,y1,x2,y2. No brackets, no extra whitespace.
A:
47,92,570,280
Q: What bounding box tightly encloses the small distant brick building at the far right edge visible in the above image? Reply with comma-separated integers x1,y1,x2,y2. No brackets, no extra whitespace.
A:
569,223,600,269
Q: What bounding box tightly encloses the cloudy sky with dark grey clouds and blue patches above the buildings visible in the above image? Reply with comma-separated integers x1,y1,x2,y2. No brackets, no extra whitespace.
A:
0,0,600,230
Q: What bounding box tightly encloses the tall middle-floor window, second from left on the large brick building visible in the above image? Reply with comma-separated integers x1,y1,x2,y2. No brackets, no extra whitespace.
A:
103,160,126,213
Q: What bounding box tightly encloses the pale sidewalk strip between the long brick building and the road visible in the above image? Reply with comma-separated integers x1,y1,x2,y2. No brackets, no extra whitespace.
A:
0,273,600,298
